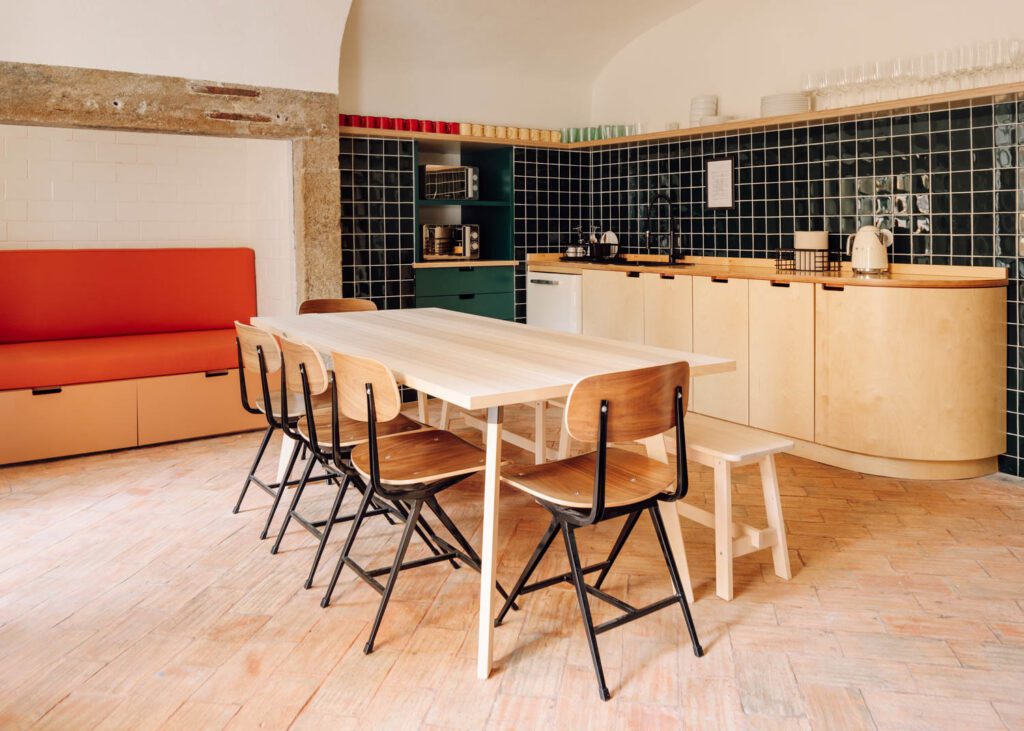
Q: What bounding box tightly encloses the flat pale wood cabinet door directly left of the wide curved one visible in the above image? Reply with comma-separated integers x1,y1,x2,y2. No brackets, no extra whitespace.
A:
749,280,814,441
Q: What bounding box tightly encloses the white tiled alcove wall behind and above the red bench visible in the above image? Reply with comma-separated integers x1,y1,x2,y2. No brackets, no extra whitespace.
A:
0,125,296,314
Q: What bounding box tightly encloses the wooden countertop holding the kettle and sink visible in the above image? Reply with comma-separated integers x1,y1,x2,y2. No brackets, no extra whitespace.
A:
527,254,1008,289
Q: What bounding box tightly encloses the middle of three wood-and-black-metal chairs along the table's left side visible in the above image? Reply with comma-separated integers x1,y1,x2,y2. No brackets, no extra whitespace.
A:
270,333,454,589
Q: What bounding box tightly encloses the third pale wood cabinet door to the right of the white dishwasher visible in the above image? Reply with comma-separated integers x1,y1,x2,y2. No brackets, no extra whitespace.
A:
690,276,750,424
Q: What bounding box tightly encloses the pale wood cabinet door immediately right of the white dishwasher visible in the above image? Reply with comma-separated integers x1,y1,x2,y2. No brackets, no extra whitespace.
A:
583,269,643,343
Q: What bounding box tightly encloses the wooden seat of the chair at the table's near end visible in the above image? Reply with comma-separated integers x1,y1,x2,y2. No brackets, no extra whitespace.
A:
502,447,676,509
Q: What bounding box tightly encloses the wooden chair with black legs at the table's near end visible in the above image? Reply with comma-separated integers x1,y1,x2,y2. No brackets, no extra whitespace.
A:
495,362,703,700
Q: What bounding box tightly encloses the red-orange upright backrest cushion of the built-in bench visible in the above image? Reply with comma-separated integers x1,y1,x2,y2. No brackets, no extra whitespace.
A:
0,248,256,344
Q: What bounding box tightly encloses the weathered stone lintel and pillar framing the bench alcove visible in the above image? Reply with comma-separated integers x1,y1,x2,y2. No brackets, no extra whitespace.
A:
0,61,341,300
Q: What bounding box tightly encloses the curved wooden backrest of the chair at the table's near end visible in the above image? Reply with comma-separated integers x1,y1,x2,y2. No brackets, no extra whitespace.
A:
565,361,690,442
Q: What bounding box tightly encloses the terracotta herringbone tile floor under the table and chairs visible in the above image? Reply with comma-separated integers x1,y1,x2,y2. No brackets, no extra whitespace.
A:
0,401,1024,729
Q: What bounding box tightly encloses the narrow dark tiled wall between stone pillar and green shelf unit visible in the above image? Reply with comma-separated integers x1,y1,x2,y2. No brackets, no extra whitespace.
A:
338,137,416,309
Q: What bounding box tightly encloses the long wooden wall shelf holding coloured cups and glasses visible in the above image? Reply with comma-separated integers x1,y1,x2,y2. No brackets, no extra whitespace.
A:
339,82,1024,149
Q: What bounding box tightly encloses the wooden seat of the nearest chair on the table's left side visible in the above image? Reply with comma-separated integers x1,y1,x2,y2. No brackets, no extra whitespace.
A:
352,429,485,485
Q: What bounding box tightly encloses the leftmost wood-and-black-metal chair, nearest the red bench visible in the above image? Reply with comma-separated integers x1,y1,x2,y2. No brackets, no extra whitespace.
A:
231,323,330,539
